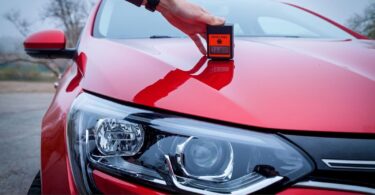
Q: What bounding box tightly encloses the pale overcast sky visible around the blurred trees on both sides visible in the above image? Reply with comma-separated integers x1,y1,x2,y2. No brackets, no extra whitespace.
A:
0,0,375,37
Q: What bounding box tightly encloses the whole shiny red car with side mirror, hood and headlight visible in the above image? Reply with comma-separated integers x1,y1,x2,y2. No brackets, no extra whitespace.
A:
25,0,375,194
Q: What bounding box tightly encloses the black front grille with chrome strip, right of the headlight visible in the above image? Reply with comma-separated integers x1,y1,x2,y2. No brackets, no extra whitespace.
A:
282,134,375,192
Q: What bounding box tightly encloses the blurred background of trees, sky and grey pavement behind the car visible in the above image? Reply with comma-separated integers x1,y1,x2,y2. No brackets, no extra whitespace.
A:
0,0,375,194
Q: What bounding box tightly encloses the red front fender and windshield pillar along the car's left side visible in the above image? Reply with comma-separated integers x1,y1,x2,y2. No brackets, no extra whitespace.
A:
41,1,100,195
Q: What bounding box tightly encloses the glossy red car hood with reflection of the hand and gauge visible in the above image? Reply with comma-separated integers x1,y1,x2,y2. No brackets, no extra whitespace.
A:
82,38,375,134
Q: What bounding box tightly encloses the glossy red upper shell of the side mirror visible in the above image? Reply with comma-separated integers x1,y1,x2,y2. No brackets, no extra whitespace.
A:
24,30,66,50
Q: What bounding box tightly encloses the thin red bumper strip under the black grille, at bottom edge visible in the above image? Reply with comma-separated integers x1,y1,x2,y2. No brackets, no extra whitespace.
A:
278,188,360,195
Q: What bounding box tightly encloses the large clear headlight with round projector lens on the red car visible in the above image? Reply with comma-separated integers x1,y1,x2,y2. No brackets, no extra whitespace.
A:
67,94,313,194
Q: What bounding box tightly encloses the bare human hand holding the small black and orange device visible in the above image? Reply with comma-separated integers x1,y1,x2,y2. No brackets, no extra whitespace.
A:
157,0,225,55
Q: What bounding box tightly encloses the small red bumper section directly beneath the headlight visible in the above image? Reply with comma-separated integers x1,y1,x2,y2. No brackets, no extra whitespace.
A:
93,170,165,195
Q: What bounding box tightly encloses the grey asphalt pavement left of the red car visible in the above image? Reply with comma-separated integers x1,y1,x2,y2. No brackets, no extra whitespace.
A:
0,92,53,194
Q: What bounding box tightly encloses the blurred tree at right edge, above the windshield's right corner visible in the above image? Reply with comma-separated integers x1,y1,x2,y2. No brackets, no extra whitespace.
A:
348,3,375,39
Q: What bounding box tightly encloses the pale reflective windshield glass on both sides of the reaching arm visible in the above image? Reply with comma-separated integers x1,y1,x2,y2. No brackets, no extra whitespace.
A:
94,0,354,39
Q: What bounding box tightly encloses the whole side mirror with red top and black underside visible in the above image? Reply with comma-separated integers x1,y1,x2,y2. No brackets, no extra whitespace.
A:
23,30,76,59
